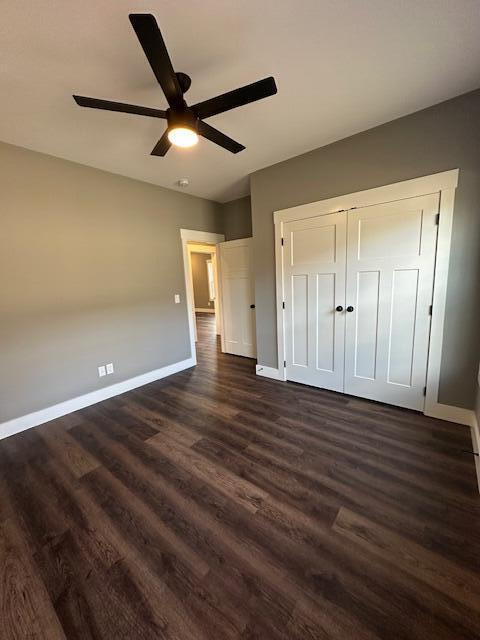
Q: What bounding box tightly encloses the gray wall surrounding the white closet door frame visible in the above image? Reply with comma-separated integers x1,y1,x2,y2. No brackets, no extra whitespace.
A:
250,91,480,408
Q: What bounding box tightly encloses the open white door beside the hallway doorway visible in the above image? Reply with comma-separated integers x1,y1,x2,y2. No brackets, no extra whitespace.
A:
217,238,256,358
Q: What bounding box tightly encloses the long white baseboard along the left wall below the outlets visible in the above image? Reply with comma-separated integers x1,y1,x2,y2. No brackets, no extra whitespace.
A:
0,358,197,440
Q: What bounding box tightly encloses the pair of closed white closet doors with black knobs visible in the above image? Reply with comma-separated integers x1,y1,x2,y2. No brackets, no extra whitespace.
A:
283,194,439,410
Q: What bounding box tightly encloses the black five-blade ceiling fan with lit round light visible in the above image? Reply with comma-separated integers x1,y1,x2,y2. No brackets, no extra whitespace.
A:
73,13,277,156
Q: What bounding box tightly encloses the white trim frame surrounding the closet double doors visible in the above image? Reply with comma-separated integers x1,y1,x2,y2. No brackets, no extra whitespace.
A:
272,169,463,422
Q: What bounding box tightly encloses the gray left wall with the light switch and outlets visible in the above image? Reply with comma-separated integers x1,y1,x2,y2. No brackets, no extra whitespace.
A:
0,144,223,423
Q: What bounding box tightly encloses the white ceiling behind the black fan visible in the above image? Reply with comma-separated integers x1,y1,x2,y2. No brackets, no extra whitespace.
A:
0,0,480,201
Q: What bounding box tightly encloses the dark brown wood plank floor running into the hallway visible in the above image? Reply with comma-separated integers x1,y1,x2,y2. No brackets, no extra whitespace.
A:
0,316,480,640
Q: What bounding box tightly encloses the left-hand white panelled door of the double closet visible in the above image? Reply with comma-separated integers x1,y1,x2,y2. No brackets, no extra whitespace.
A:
283,212,347,391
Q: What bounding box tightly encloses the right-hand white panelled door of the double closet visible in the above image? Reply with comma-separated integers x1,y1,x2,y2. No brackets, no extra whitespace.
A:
345,194,439,410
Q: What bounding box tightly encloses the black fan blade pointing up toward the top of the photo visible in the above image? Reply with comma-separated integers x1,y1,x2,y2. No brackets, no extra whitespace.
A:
129,13,183,107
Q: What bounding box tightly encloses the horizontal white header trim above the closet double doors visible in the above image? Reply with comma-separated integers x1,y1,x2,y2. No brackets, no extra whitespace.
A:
273,169,459,224
